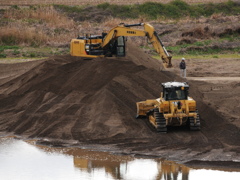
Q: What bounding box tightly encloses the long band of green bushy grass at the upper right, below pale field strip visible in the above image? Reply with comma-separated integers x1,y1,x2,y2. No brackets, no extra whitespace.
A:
94,0,240,19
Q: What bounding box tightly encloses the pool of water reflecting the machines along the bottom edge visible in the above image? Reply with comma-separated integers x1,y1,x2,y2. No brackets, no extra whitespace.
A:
0,137,240,180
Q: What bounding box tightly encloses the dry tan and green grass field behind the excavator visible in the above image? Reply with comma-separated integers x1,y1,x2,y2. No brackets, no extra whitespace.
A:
0,0,240,58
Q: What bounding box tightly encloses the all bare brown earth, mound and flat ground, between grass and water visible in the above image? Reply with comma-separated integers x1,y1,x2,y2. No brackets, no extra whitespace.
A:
0,46,240,164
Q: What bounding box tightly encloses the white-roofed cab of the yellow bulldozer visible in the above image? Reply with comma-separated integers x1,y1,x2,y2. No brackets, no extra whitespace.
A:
162,82,189,101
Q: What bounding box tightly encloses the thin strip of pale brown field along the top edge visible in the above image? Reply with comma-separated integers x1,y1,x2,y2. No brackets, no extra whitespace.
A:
0,0,233,5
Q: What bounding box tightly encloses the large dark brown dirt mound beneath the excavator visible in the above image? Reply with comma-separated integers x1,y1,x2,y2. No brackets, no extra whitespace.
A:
0,46,240,160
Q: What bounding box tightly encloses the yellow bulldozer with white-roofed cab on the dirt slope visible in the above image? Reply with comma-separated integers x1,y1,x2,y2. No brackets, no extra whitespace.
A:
136,82,200,132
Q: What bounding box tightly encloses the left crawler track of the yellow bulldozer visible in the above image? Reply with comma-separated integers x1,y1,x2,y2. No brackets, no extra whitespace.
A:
153,108,167,133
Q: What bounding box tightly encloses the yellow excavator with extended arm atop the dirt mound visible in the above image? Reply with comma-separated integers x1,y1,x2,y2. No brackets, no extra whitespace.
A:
70,23,172,67
